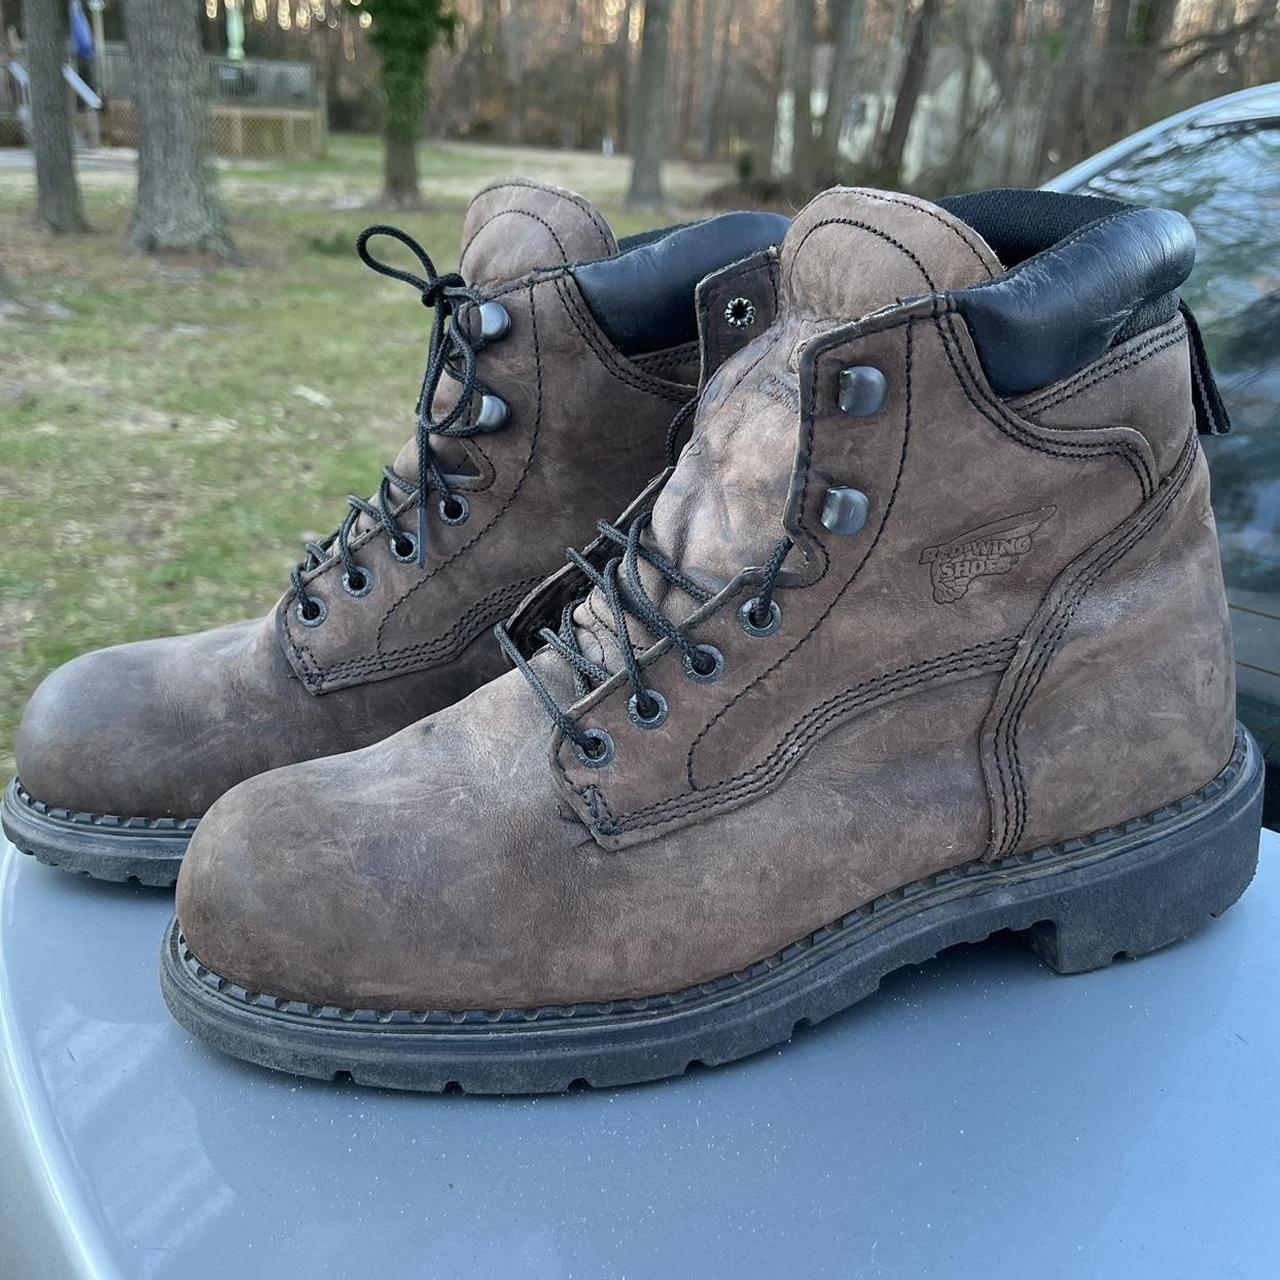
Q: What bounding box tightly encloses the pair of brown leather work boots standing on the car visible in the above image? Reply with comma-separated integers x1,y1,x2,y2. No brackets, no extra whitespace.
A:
4,182,1262,1092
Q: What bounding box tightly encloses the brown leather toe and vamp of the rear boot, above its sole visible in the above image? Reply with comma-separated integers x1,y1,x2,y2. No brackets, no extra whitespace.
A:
15,618,503,818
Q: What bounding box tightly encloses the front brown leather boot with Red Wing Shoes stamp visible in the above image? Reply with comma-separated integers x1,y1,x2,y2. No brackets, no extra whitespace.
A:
163,189,1261,1092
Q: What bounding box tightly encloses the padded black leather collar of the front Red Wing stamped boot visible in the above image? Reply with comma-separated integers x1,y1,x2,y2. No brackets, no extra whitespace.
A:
950,192,1196,396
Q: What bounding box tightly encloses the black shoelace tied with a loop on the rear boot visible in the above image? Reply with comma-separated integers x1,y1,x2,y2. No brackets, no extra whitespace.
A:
291,225,485,620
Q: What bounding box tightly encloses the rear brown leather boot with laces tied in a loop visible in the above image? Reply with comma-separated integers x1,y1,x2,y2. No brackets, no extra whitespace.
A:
4,179,786,884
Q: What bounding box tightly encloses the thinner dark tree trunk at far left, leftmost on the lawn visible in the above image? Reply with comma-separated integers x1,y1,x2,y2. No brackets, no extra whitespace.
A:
23,0,88,236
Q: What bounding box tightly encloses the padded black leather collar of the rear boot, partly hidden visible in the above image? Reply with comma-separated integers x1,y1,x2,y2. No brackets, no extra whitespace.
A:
570,212,791,356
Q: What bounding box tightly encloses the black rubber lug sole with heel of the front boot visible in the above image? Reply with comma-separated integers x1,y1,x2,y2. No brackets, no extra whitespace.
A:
160,730,1263,1093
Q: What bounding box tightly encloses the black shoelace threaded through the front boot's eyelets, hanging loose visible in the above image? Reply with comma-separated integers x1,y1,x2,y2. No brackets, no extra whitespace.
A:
494,512,792,764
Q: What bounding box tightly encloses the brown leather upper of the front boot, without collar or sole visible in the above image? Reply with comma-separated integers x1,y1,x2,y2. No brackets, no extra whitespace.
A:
178,185,1230,1009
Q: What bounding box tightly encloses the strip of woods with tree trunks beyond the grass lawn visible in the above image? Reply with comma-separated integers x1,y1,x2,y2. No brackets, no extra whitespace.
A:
0,0,1280,257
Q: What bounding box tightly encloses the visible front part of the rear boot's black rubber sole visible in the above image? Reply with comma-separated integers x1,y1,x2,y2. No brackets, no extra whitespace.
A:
0,778,196,888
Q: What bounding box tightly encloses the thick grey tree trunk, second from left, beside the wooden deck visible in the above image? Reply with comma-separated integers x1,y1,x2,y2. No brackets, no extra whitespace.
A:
124,0,234,257
